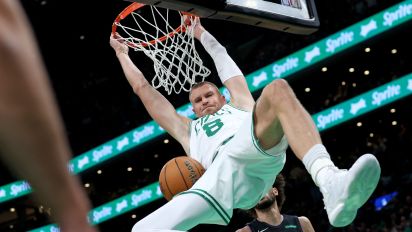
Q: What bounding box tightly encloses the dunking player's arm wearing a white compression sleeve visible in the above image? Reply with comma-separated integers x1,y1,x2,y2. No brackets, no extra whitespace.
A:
195,20,255,111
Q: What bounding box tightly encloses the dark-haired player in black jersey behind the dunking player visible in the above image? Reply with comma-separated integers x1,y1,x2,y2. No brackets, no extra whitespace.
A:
236,174,315,232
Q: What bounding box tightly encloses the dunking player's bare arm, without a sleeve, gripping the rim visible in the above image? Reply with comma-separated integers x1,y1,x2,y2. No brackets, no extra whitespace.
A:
110,35,190,152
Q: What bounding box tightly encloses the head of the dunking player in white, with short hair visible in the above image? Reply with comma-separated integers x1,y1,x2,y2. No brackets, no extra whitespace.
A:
189,81,226,118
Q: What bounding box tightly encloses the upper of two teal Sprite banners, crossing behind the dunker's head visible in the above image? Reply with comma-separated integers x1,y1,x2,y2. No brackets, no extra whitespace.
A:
0,0,412,203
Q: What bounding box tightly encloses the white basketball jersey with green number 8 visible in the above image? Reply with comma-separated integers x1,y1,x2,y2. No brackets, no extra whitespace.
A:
190,104,252,169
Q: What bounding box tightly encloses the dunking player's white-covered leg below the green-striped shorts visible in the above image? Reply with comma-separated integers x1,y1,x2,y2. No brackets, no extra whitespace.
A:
132,194,221,232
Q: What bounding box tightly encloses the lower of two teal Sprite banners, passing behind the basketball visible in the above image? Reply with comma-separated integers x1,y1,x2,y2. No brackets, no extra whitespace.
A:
31,73,412,232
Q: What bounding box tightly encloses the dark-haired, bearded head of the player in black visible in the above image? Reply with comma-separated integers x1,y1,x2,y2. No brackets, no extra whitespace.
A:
248,174,285,218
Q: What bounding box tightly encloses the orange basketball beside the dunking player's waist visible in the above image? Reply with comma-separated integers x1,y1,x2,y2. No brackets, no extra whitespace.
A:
159,156,205,201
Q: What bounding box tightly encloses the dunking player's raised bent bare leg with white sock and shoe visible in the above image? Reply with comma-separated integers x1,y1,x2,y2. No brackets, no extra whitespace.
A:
254,79,380,226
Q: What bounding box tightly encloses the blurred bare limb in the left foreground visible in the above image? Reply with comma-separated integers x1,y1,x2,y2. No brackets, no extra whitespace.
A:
0,0,95,232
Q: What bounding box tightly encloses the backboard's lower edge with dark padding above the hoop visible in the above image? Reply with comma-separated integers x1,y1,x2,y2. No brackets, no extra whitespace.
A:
124,0,319,35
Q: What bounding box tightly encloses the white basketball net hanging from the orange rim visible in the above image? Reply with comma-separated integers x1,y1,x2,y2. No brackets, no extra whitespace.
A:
117,6,210,95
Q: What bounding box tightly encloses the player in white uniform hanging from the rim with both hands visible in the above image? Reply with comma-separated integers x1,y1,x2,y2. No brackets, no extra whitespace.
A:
110,17,380,232
